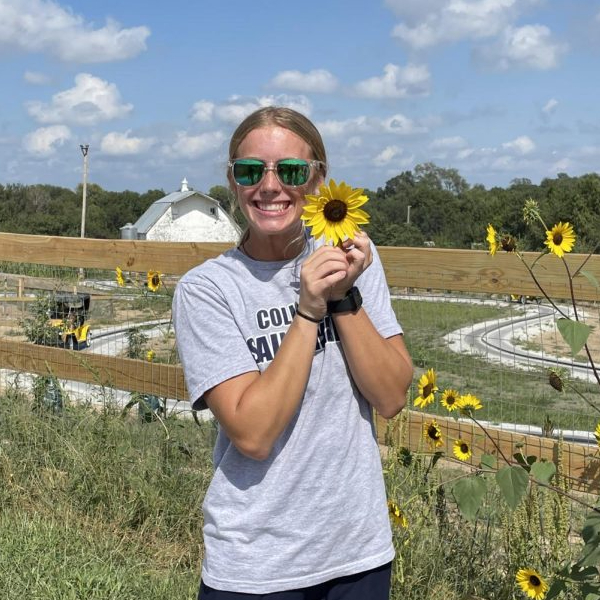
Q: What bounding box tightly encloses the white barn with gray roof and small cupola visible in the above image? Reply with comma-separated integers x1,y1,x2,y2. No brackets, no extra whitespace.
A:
121,179,241,242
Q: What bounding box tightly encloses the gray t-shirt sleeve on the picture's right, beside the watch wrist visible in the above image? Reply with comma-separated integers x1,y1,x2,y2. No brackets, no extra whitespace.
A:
356,243,402,338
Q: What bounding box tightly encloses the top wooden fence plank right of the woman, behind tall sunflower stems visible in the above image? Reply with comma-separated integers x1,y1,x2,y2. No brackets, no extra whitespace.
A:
378,246,600,300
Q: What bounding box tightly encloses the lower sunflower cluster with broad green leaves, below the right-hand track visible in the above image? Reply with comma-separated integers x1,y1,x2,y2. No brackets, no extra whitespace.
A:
408,369,600,600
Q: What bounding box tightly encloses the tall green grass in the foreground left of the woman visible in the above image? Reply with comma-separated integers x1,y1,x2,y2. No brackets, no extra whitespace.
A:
0,394,215,600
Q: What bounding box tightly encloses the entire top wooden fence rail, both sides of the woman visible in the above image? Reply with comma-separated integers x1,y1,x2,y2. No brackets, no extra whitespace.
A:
0,233,600,300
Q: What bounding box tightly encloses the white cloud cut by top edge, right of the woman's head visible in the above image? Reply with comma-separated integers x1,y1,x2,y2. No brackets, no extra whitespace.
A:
387,0,536,49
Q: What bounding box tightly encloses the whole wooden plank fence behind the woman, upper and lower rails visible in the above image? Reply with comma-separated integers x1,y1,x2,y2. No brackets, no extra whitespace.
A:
0,233,600,491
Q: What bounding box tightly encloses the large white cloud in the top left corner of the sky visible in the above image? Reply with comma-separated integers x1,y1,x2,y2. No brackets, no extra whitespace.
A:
0,0,150,63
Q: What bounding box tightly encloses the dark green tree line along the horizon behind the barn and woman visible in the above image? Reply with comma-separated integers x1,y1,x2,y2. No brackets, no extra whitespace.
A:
0,163,600,252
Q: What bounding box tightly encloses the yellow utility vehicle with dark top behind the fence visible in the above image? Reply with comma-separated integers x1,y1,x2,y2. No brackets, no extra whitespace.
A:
48,293,92,350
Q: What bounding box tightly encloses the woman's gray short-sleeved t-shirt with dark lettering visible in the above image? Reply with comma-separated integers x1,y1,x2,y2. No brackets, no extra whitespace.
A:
173,240,402,594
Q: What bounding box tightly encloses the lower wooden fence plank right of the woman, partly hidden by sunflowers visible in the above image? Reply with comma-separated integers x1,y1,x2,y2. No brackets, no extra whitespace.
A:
376,410,600,493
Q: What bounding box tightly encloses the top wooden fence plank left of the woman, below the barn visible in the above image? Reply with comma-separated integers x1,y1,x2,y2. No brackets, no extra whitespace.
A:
0,233,233,275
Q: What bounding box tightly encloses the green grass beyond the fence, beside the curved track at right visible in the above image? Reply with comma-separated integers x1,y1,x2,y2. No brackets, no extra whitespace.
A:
394,300,600,431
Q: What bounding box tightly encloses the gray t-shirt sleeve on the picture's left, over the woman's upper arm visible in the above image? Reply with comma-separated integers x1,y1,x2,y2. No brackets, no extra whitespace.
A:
173,276,258,410
